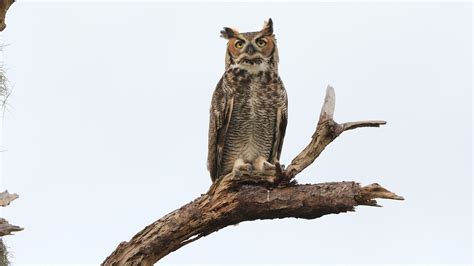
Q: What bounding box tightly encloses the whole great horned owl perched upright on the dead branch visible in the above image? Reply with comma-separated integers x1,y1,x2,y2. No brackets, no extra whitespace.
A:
207,19,288,181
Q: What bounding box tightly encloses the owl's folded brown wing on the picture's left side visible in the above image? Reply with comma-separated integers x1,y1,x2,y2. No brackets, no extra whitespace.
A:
207,79,234,181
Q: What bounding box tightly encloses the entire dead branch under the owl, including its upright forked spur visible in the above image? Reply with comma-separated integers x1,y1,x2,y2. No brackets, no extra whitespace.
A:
103,87,403,265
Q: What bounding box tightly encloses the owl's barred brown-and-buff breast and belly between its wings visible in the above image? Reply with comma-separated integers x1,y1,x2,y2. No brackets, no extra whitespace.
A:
223,70,286,175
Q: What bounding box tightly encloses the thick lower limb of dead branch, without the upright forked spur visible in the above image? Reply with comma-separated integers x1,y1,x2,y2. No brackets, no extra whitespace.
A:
103,181,404,265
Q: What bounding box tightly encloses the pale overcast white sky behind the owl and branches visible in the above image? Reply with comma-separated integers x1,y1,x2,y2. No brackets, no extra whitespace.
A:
2,2,472,265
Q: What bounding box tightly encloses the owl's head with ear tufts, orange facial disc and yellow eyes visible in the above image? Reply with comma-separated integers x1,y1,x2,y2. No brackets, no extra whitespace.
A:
221,19,278,72
